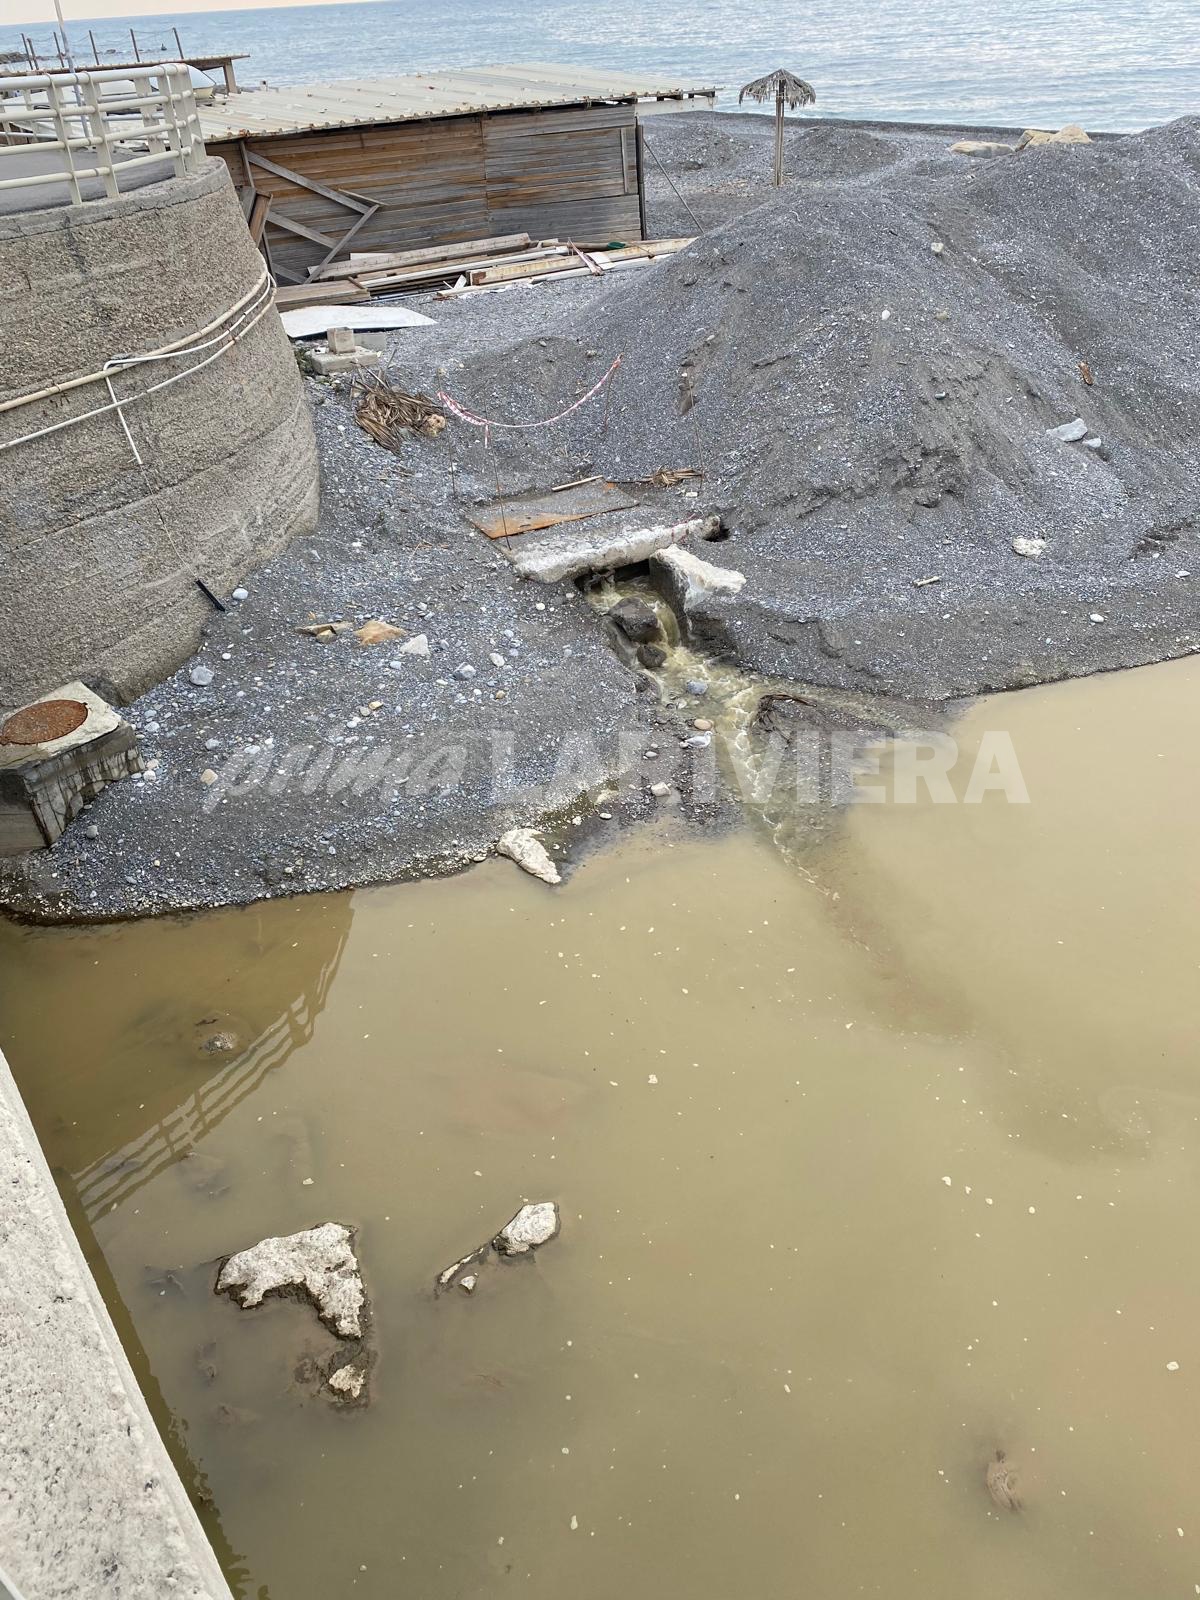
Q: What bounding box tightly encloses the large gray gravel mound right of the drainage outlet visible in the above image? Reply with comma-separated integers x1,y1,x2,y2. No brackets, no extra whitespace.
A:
462,118,1200,699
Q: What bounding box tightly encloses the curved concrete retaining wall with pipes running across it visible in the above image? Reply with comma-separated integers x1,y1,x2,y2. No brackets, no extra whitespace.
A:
0,160,317,706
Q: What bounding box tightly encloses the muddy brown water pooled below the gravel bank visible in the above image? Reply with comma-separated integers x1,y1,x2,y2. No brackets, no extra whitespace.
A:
0,662,1200,1600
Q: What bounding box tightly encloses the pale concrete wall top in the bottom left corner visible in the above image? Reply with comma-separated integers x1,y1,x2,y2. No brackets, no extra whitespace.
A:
0,1054,232,1600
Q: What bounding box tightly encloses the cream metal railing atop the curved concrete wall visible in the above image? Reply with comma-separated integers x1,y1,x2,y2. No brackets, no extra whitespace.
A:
0,61,205,205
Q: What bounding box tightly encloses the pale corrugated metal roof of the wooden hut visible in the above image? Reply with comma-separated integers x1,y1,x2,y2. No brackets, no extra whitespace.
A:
198,61,715,142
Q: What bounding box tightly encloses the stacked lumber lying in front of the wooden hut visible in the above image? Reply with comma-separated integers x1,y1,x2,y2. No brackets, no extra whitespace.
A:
277,234,691,307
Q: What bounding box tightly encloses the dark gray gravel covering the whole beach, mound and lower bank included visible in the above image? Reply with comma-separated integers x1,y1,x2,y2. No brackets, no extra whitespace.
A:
0,115,1200,917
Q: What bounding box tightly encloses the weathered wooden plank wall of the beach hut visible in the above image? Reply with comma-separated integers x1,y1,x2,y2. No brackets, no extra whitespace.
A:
208,106,642,283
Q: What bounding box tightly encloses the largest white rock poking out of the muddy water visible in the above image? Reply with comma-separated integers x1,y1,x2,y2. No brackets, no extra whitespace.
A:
216,1222,366,1339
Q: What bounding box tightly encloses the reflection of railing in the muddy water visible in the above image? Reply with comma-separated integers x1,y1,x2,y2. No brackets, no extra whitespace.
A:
72,934,346,1222
